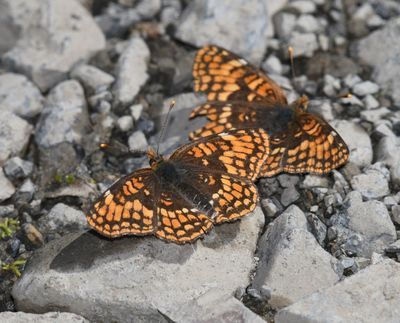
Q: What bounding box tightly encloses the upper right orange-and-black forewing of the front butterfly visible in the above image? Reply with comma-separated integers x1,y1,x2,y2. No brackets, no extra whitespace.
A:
170,129,269,180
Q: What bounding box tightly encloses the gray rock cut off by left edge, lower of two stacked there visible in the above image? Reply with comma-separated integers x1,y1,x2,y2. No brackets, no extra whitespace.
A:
0,109,33,165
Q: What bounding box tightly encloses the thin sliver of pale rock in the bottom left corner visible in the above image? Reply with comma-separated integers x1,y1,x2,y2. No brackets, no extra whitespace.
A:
0,312,89,323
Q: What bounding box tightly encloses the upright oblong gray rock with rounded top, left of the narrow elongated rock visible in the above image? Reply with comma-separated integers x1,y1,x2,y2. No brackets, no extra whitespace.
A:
35,80,89,148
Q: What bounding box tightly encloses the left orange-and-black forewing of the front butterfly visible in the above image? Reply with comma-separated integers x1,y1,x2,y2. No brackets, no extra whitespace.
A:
86,168,157,238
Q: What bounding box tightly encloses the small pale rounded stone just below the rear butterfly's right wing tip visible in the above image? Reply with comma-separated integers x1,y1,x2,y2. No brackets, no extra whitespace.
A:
350,165,390,200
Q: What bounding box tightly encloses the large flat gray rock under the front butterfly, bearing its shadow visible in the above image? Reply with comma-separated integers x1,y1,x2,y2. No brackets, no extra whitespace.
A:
12,208,264,322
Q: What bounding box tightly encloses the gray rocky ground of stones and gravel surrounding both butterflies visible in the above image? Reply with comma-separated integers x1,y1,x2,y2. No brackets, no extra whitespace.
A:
0,0,400,323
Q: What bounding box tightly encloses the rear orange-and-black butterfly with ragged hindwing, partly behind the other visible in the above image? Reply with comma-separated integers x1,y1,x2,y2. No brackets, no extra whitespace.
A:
190,46,349,177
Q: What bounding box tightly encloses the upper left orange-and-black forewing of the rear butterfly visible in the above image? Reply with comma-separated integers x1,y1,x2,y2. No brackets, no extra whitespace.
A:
193,45,287,104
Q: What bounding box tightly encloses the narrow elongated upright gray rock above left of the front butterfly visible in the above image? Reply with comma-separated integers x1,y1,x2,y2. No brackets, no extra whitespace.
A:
114,37,150,105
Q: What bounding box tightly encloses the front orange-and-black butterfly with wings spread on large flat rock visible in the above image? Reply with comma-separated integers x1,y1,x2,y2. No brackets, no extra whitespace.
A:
86,129,269,244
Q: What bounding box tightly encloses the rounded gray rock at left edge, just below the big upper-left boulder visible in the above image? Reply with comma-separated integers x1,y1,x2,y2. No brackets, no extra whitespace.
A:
0,73,43,118
